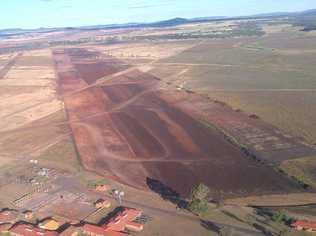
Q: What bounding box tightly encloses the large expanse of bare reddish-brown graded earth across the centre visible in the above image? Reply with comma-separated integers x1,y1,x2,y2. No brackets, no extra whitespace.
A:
54,49,313,198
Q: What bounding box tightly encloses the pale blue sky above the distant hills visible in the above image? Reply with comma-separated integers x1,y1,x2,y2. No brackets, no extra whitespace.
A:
0,0,316,29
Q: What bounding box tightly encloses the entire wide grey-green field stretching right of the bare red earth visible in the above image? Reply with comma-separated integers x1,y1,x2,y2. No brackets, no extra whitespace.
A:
151,28,316,144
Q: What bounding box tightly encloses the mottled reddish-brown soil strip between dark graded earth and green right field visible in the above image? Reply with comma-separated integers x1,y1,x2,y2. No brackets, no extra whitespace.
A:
158,93,316,163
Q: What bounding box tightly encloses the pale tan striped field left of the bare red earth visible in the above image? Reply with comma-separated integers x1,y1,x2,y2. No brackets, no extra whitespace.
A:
0,50,69,169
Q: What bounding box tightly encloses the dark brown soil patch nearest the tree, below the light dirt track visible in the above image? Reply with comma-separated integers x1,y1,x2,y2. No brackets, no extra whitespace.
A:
144,161,295,198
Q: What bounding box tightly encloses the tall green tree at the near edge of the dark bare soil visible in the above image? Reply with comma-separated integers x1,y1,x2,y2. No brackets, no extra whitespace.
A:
188,183,210,216
